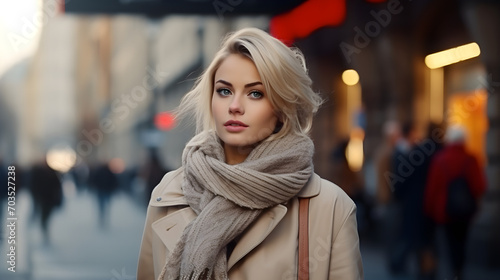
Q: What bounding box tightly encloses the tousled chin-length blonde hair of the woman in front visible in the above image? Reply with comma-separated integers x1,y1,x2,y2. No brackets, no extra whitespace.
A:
176,28,322,139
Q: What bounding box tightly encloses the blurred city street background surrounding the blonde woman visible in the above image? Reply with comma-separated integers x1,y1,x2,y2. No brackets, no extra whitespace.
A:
0,0,500,280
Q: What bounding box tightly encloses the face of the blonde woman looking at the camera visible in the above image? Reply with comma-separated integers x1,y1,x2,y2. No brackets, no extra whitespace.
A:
212,54,278,161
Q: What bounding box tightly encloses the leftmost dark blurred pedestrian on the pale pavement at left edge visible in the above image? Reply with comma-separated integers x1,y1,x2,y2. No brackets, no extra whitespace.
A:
29,160,63,245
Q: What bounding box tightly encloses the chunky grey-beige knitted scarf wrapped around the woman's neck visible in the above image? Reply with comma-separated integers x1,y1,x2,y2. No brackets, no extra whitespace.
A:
159,132,314,280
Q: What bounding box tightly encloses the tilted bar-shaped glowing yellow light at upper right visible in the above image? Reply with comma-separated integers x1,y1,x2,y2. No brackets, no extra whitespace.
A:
425,43,481,69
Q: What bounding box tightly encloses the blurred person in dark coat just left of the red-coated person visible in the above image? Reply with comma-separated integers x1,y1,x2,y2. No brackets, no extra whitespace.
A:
389,122,440,279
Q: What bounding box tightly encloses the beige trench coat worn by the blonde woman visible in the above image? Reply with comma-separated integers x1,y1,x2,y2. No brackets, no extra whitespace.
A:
137,168,363,280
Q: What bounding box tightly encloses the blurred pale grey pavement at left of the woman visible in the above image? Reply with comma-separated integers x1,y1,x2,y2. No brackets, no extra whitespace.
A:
0,182,146,280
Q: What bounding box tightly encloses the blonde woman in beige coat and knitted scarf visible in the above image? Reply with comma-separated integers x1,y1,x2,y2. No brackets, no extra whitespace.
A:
137,28,363,280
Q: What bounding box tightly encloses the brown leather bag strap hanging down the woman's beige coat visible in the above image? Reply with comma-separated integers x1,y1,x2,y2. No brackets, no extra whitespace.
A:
298,198,309,280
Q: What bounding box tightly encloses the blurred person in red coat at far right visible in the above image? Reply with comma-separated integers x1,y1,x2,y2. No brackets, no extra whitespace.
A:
424,126,486,279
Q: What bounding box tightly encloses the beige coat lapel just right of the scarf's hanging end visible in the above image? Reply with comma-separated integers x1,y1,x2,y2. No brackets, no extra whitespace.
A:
227,205,287,270
